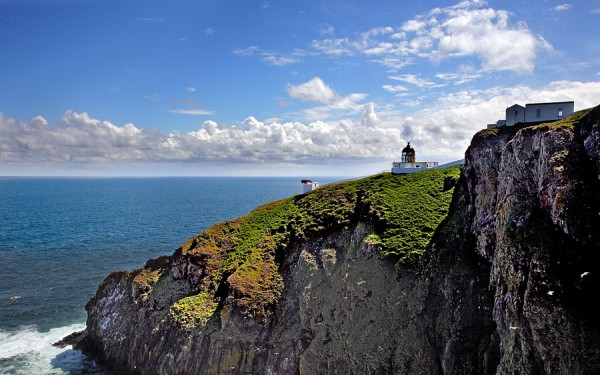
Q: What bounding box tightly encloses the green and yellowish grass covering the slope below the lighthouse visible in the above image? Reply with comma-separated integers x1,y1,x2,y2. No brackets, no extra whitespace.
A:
170,167,460,327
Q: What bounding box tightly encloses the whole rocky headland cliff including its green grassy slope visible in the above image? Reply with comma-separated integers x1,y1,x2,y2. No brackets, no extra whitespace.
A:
78,108,600,374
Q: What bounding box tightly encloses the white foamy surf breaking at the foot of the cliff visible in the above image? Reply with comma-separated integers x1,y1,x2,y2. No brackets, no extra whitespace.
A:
0,324,100,375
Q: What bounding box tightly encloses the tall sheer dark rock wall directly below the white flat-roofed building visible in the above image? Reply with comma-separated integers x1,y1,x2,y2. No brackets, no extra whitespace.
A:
465,109,600,374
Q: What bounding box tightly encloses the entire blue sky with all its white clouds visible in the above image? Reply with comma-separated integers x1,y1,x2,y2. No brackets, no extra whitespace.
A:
0,0,600,177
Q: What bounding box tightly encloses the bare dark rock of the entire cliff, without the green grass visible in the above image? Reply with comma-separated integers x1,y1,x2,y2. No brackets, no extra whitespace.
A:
74,109,600,375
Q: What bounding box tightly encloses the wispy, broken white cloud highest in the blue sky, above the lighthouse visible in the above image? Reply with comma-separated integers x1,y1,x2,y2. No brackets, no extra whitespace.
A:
310,0,552,73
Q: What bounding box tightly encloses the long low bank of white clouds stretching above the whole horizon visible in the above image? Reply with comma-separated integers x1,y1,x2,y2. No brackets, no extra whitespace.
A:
0,81,600,170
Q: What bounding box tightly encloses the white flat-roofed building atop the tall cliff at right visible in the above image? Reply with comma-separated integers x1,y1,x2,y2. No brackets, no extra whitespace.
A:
487,101,575,129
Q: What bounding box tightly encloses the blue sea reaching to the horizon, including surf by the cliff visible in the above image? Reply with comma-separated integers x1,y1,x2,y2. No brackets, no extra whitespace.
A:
0,177,343,375
